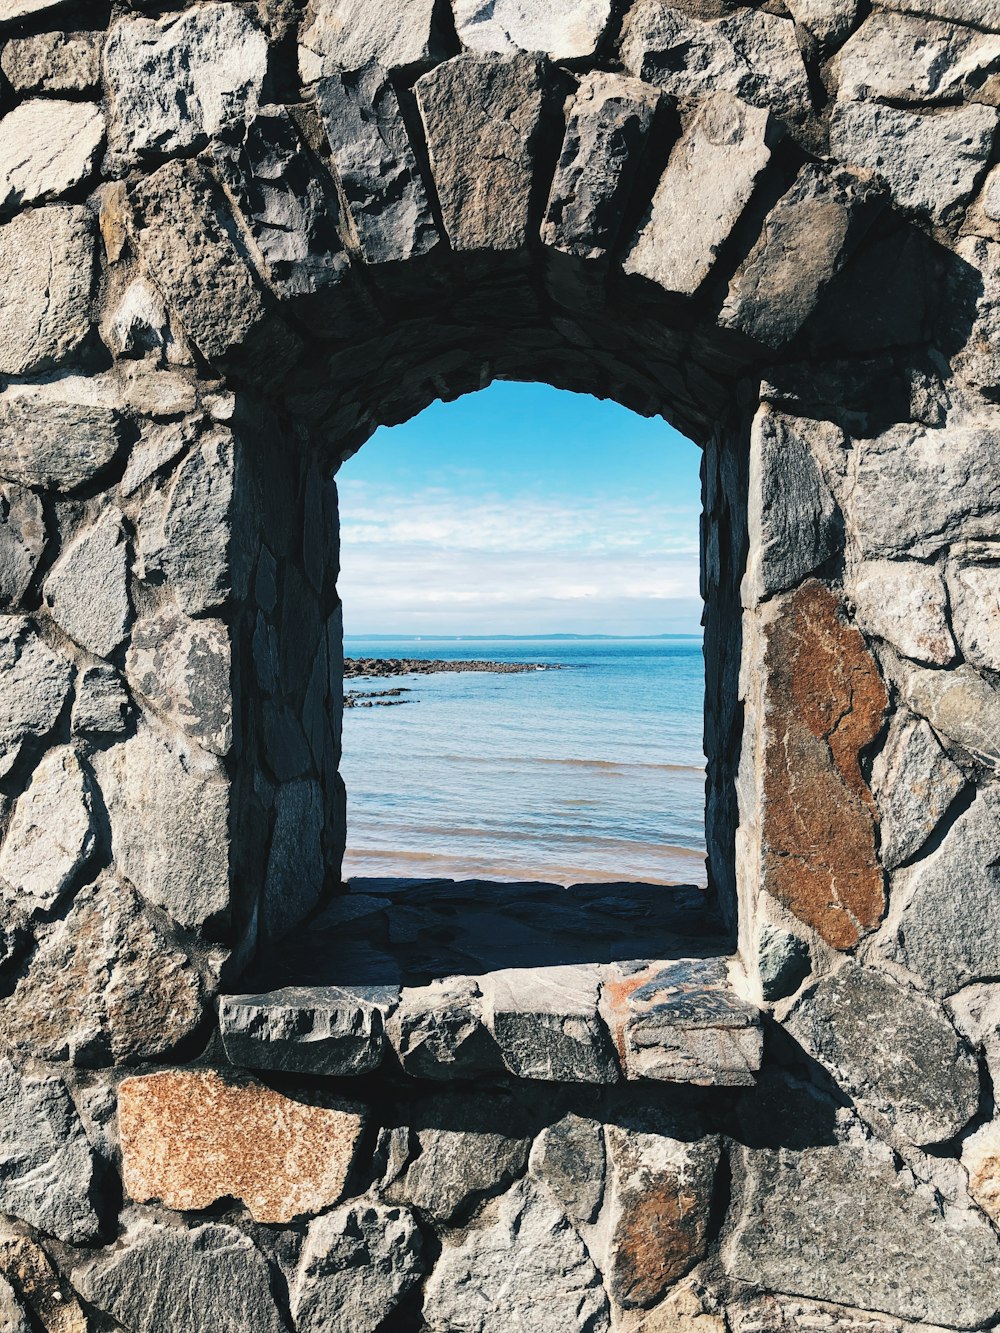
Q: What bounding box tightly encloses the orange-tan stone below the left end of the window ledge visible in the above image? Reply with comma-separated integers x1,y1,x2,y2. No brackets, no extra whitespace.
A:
119,1070,364,1222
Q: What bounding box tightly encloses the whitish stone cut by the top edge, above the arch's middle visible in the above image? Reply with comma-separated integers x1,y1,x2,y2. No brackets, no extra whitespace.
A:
455,0,611,60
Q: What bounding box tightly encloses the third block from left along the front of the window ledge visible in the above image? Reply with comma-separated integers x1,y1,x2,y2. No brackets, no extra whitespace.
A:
481,966,619,1082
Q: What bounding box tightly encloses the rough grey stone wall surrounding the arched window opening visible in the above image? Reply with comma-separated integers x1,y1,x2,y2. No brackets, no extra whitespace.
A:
0,0,1000,1333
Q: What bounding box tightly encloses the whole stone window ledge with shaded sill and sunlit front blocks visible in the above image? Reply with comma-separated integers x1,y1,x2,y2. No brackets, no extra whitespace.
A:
219,880,763,1086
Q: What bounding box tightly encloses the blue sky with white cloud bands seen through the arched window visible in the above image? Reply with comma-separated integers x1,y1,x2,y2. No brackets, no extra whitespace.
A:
337,383,701,635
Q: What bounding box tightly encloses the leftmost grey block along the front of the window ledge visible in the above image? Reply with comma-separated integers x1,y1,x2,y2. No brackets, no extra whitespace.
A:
219,986,399,1074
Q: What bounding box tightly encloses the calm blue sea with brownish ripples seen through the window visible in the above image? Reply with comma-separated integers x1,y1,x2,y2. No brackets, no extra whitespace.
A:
343,637,705,884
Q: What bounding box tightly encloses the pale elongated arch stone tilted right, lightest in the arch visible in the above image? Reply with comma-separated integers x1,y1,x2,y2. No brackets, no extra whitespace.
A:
623,92,781,296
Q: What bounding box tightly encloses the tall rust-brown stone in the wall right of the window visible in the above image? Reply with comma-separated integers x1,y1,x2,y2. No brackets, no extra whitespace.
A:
763,580,888,949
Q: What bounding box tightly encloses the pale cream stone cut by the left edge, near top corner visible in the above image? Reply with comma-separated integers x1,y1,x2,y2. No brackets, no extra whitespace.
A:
0,97,104,212
